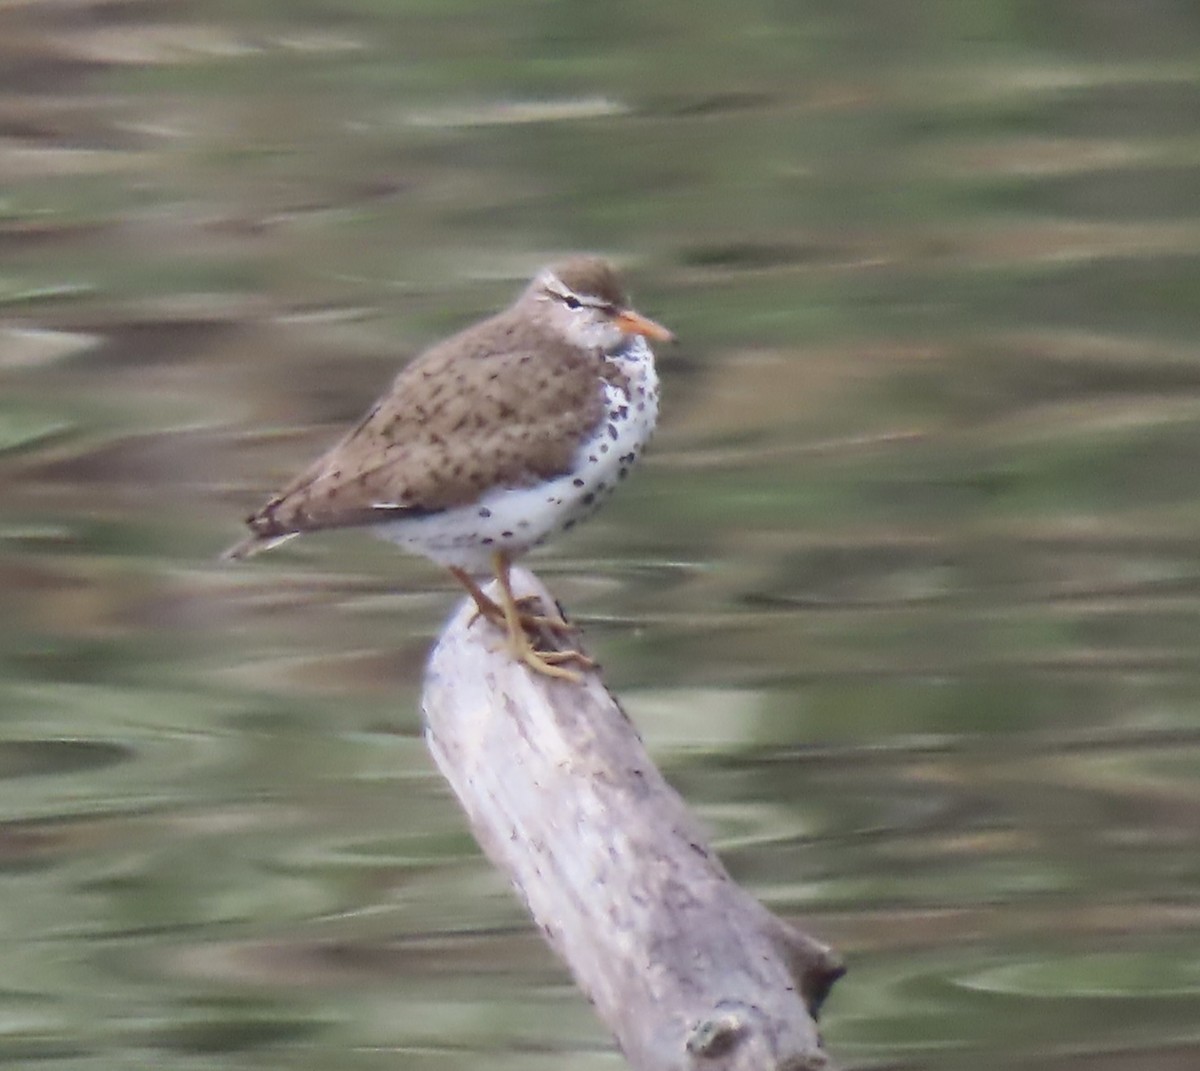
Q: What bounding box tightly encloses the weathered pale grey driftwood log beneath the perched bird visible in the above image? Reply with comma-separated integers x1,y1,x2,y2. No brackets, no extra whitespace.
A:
422,569,842,1071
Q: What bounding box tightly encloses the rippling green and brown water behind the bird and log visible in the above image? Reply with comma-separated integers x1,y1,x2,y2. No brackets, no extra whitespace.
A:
0,0,1200,1071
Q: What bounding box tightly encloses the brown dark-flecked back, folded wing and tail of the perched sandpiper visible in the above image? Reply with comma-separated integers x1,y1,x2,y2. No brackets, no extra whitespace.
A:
229,313,605,557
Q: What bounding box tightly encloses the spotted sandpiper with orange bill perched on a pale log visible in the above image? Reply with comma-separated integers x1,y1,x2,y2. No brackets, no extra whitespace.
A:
222,255,674,682
